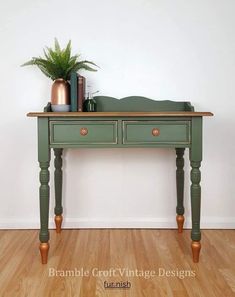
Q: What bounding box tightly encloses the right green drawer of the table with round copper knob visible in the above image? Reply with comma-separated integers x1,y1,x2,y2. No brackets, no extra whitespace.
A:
122,121,190,144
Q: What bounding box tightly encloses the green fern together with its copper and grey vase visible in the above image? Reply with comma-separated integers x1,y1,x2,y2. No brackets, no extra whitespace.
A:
21,38,97,111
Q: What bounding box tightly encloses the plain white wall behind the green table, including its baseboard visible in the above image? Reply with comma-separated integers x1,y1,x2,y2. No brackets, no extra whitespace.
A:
0,0,235,228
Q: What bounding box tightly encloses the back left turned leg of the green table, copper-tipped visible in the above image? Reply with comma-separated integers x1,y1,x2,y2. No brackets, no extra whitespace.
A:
54,148,63,233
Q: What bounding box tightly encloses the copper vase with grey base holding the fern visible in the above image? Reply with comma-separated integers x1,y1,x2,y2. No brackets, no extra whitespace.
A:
51,78,70,111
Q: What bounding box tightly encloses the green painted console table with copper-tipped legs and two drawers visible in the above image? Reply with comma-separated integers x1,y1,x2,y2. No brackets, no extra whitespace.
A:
27,96,213,264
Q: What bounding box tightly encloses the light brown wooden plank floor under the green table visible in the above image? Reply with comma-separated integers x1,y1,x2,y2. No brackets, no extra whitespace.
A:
0,229,235,297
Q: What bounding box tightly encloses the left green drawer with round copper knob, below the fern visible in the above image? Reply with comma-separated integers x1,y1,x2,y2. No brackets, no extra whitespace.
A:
50,121,117,145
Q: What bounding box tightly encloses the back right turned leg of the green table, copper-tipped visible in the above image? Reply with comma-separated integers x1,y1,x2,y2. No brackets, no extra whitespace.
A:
176,148,185,233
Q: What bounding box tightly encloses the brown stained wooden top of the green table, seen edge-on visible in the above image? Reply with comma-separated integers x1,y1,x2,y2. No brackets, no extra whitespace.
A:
27,111,214,117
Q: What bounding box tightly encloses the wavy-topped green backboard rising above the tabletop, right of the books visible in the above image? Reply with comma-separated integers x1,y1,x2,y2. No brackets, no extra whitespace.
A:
94,96,194,112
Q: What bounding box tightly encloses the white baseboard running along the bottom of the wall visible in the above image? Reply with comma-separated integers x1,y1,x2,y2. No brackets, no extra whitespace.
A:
0,217,235,229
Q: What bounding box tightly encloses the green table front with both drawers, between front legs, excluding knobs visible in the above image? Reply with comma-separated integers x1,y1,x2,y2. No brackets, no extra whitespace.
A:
49,117,191,148
